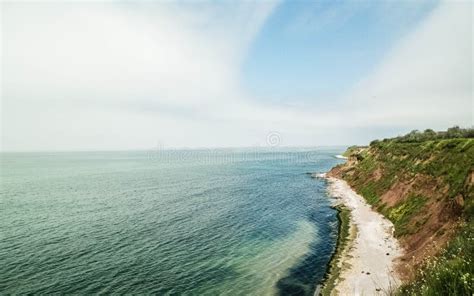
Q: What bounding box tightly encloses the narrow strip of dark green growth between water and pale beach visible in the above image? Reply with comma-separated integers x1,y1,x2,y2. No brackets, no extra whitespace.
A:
321,205,352,296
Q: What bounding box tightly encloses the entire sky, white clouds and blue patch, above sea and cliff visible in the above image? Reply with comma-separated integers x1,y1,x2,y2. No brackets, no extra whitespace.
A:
0,0,474,151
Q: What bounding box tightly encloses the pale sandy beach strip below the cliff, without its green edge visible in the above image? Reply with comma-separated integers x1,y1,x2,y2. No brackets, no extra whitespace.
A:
322,175,402,295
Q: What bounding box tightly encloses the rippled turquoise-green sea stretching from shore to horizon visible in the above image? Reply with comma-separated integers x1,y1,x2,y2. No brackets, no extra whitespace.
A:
0,149,342,295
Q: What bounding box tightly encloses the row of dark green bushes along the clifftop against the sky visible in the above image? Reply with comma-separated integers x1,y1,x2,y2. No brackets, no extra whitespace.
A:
370,126,474,145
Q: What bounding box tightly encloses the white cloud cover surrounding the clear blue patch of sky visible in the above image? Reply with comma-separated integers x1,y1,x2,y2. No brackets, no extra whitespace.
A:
2,2,473,150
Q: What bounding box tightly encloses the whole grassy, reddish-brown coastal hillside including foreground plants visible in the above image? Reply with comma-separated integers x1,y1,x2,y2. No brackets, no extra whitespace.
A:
330,127,474,295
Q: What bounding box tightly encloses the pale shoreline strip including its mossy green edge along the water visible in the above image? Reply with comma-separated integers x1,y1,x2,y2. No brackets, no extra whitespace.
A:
313,174,402,295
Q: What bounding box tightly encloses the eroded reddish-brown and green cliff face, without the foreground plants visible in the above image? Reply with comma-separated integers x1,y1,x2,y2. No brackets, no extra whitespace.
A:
329,139,474,278
